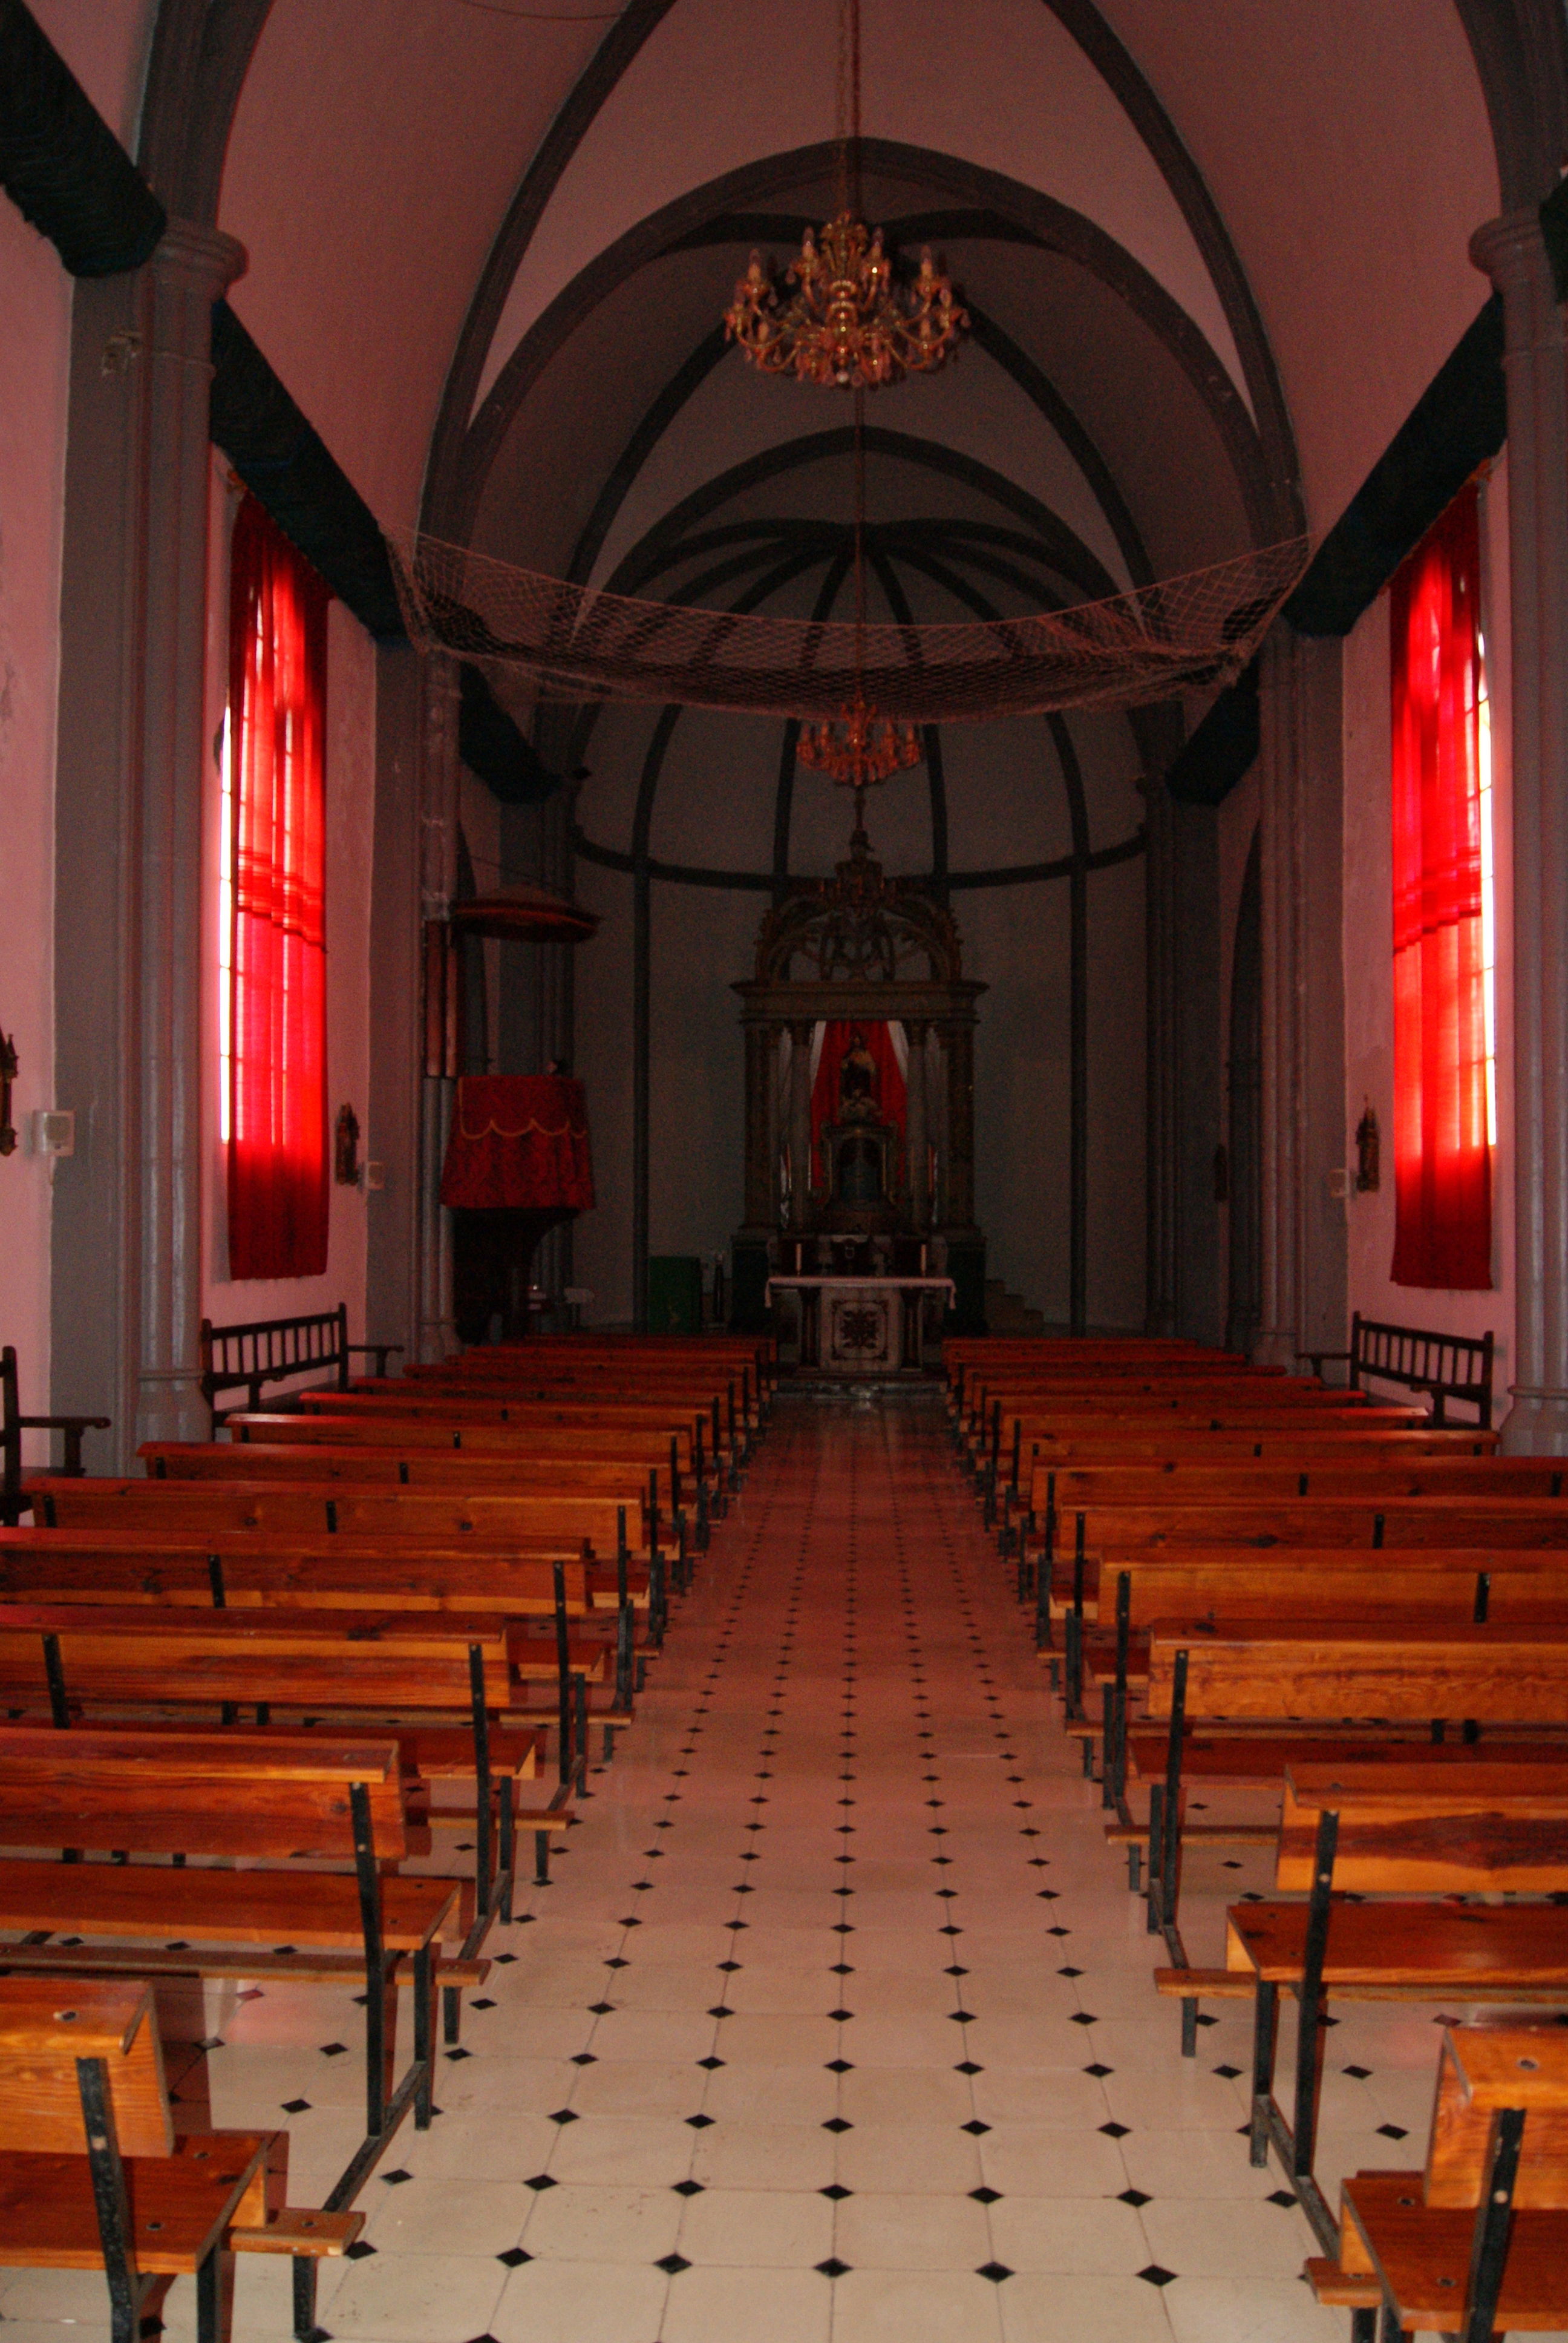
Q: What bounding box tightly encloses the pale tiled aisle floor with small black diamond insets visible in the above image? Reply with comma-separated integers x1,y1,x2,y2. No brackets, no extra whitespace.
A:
0,1397,1518,2343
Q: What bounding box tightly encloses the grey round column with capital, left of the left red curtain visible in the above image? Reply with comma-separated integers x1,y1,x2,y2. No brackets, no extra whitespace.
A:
139,220,246,1441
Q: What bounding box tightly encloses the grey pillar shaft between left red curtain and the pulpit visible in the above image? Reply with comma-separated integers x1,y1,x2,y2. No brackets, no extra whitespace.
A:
417,654,459,1362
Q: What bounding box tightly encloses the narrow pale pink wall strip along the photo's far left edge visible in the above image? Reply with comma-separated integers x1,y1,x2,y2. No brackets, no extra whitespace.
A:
0,199,70,1462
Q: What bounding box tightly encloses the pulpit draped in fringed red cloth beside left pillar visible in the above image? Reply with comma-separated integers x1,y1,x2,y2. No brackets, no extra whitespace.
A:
440,1073,593,1343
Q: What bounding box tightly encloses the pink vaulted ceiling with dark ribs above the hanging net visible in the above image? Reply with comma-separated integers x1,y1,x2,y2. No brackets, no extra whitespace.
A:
35,0,1563,871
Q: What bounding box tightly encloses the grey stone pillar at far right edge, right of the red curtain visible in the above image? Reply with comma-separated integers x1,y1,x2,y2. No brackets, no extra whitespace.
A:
1469,209,1568,1455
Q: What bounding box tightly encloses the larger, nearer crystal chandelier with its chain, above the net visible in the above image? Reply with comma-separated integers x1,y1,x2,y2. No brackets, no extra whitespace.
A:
724,0,968,392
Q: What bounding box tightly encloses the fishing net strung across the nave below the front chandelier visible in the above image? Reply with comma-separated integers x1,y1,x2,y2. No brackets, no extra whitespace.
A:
389,537,1310,724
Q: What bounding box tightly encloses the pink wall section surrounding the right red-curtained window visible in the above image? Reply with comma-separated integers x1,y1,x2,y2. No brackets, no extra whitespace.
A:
1343,464,1514,1392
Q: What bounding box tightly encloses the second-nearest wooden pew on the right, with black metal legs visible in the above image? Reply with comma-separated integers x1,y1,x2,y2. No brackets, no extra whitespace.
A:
1226,1750,1568,2244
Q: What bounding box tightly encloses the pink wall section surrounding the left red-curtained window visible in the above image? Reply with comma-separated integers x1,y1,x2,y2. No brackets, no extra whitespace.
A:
201,457,375,1368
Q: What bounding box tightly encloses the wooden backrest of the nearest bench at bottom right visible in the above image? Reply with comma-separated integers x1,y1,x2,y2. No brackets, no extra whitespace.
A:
1423,2024,1568,2212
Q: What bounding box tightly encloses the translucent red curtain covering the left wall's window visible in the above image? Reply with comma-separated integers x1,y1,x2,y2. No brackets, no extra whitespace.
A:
227,497,330,1277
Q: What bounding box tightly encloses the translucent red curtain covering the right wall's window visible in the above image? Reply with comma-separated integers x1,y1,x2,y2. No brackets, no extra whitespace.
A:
1390,487,1491,1289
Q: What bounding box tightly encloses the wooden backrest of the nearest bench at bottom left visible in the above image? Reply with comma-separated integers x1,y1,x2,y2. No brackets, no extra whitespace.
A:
0,1978,174,2155
